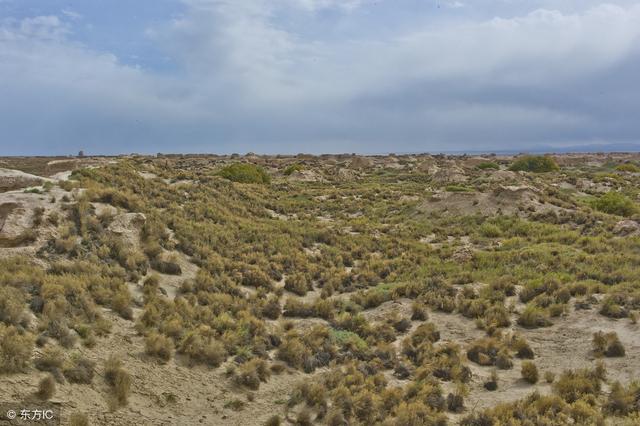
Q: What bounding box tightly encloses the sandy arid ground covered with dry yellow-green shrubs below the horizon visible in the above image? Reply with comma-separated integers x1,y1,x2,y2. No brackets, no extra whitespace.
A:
0,154,640,426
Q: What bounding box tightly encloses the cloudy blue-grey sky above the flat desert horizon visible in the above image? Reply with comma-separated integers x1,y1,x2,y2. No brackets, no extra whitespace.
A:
0,0,640,155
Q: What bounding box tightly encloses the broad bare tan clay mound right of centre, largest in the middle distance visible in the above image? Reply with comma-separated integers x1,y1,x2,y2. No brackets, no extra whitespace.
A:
419,186,544,215
